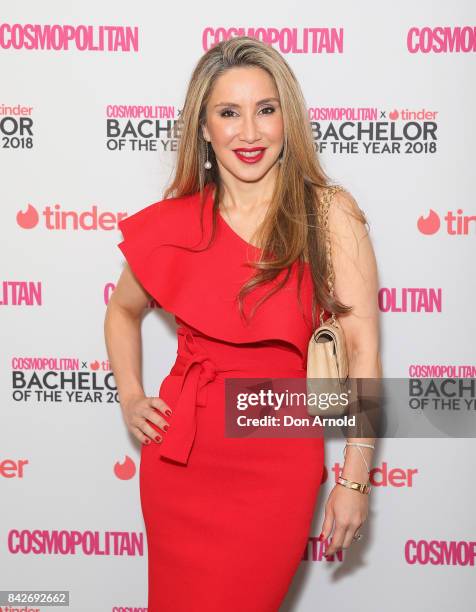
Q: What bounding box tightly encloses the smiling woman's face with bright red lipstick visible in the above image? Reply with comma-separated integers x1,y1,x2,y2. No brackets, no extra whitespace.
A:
203,66,284,182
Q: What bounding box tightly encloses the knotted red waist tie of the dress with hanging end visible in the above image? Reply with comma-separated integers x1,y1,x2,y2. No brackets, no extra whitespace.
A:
160,327,302,465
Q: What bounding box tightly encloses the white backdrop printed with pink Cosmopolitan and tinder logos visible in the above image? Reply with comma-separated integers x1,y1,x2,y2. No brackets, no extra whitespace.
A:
0,0,476,612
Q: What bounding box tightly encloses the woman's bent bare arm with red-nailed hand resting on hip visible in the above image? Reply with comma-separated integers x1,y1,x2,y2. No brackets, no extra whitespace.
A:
104,264,171,444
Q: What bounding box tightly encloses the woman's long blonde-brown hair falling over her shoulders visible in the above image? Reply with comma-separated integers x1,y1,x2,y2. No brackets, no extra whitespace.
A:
164,36,367,328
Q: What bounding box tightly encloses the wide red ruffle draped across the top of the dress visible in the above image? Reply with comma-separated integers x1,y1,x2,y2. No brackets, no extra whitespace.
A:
118,184,318,360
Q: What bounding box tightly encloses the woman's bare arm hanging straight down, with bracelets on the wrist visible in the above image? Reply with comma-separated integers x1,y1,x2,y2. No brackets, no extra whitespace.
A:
320,191,382,555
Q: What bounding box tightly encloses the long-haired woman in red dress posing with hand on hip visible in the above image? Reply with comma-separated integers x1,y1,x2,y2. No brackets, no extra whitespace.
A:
105,37,380,612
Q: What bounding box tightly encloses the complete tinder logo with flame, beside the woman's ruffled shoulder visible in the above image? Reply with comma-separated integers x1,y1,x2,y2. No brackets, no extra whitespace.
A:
16,204,127,231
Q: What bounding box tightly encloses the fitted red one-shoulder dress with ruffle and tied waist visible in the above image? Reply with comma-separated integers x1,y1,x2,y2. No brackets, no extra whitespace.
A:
118,183,324,612
